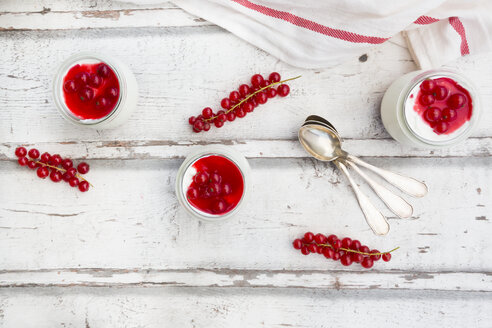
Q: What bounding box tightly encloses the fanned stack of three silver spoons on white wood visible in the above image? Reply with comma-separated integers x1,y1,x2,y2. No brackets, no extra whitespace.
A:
299,115,427,235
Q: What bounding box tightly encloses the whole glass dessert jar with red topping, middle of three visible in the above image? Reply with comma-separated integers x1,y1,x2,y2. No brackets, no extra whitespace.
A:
176,145,251,221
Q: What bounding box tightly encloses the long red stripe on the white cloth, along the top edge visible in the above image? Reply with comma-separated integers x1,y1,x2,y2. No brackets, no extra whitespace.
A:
231,0,389,44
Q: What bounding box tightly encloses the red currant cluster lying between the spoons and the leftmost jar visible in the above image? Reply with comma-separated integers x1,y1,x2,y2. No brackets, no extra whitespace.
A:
188,72,300,133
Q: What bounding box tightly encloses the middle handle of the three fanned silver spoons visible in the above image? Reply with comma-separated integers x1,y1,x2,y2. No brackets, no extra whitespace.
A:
346,161,413,218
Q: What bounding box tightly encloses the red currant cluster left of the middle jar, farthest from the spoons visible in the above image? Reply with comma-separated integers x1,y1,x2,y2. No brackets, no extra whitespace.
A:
15,147,89,192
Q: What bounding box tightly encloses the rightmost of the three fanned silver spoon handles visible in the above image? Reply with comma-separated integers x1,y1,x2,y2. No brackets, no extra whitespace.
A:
347,155,427,197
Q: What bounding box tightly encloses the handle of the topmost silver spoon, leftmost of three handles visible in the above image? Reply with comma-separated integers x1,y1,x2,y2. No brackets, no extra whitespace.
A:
335,161,389,235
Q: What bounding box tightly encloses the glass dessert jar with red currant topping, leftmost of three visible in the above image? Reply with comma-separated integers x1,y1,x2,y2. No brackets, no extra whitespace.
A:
53,52,138,129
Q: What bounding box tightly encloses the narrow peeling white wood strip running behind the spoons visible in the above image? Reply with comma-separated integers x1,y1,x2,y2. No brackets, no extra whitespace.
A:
0,137,492,161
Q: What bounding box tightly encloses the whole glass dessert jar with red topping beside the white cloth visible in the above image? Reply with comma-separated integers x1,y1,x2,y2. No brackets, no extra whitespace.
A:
381,69,481,148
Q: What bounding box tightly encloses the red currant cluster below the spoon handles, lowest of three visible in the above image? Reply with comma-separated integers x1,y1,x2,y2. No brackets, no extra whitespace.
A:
292,232,399,269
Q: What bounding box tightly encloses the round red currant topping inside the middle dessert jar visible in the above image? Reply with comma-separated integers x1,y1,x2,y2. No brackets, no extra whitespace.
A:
186,155,244,215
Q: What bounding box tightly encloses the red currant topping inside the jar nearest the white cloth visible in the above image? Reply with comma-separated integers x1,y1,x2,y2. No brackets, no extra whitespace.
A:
414,77,473,135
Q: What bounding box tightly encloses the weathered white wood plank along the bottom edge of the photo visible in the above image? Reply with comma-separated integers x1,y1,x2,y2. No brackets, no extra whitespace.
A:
0,287,492,328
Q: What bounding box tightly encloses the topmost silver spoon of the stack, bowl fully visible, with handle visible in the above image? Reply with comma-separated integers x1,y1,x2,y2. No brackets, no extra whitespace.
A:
299,124,389,235
